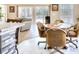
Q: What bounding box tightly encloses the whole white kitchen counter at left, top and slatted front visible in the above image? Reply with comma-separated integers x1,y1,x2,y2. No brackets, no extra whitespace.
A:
0,23,24,54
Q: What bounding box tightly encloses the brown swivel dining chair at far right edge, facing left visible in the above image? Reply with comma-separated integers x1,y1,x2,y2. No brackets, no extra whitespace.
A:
67,24,79,48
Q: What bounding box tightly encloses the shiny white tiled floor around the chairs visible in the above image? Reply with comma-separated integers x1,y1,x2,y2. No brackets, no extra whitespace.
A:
18,25,79,54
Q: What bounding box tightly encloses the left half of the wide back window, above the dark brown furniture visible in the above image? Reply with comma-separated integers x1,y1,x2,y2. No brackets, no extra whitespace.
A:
18,6,32,18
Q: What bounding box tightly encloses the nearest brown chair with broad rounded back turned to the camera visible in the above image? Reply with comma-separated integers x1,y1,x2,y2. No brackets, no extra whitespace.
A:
46,29,66,54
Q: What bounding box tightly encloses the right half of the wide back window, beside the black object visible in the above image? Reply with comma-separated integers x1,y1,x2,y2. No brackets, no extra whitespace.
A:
35,6,49,22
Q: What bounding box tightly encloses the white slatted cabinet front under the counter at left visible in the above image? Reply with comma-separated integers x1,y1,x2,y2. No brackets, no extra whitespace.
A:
0,28,17,54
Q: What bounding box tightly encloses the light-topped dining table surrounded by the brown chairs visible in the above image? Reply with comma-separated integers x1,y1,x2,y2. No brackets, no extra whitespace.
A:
44,23,72,34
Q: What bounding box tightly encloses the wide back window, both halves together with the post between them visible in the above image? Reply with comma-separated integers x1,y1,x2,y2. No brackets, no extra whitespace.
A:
18,5,49,22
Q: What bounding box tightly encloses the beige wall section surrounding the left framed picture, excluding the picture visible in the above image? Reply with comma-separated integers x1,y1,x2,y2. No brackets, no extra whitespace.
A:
7,4,18,19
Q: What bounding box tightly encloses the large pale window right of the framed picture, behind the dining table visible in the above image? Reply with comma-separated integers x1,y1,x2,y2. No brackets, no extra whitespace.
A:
59,4,73,23
